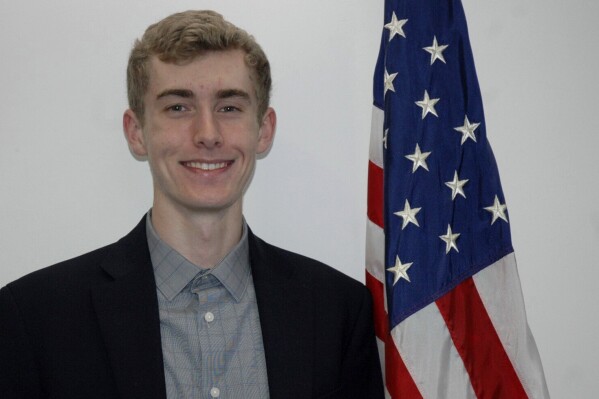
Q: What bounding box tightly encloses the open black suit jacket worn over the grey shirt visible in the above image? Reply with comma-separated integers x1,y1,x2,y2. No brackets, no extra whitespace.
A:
0,218,383,399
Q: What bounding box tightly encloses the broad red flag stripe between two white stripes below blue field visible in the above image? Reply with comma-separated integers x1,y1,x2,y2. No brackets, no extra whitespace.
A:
437,278,527,399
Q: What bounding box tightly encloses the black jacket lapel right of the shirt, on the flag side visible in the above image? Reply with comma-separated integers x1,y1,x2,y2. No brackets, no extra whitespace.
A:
248,230,315,399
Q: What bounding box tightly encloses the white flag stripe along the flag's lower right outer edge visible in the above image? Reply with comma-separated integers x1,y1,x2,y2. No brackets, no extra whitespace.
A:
473,253,549,398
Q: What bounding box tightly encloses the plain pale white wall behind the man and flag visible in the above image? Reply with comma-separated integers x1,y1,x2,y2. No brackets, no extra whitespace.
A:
0,0,599,398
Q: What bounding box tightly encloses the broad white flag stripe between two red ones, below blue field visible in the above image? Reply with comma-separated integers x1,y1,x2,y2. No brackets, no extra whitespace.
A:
391,302,476,399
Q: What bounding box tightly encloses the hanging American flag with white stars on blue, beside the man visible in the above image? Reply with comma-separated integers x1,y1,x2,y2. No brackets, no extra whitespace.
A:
366,0,549,399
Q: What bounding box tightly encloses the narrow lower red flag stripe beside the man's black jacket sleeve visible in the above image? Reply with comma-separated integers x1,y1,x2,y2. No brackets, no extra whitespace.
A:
366,272,422,399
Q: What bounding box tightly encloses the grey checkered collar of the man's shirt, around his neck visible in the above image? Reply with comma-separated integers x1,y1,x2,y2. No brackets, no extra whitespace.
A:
146,211,251,302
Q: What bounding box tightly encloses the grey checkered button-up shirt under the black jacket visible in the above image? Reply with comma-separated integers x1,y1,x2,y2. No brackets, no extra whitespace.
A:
146,214,269,399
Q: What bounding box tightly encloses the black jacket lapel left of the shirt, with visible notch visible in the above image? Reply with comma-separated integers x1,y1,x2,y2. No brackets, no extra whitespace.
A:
92,217,166,399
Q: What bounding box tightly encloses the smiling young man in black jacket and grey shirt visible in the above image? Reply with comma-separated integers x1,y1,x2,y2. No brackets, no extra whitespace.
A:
0,11,383,399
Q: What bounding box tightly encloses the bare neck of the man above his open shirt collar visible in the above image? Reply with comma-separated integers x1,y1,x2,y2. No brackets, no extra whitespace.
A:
152,201,243,268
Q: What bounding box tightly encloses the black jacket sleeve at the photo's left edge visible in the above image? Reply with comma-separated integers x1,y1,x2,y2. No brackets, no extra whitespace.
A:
0,286,41,399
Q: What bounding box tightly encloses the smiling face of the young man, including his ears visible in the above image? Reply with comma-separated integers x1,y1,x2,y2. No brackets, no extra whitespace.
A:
123,50,276,217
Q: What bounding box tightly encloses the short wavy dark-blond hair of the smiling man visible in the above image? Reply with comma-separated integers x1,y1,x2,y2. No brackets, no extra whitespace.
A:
127,10,272,123
